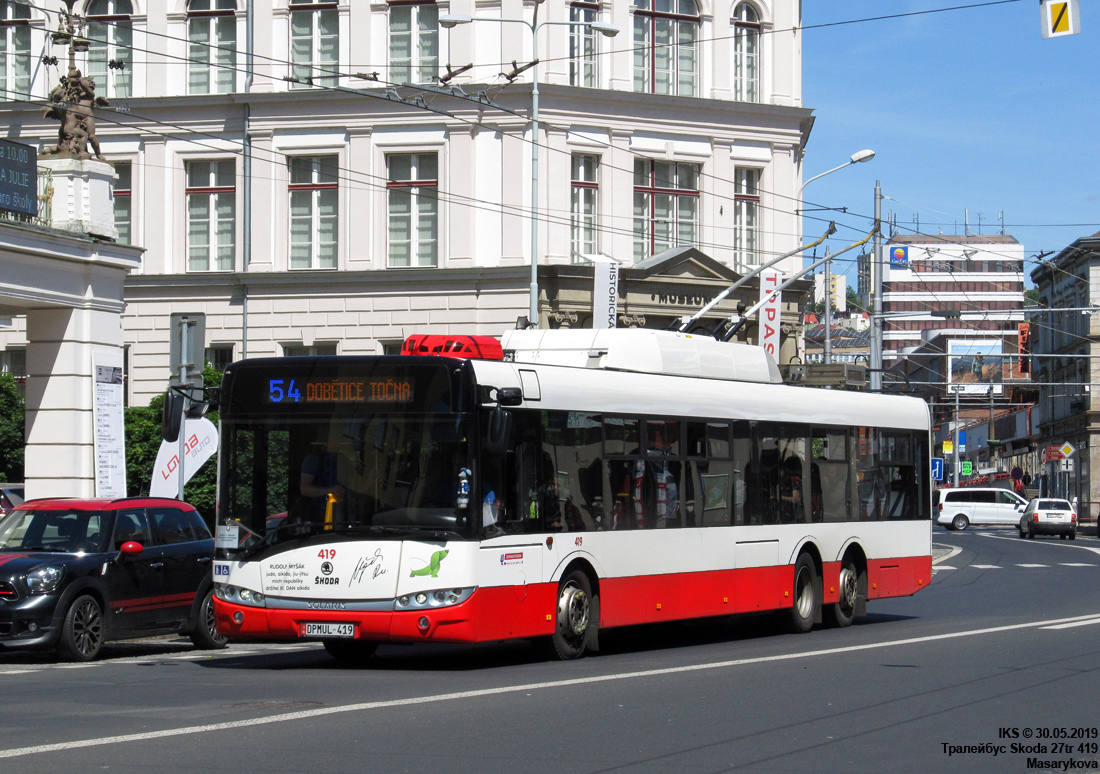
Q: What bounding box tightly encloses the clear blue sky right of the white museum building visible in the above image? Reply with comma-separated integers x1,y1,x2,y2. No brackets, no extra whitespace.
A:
802,0,1100,286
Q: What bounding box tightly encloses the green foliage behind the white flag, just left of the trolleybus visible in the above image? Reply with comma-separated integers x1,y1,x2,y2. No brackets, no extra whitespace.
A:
125,363,221,524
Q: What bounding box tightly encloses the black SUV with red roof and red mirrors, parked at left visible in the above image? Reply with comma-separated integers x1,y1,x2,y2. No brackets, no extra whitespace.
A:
0,497,226,661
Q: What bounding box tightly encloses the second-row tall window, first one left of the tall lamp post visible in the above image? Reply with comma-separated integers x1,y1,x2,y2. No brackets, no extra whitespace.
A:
386,153,439,268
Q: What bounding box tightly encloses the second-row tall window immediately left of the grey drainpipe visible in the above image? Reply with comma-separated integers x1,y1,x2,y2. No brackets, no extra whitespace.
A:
186,159,237,272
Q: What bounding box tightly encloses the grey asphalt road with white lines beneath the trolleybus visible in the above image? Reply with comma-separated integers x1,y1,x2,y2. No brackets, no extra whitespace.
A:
0,528,1100,774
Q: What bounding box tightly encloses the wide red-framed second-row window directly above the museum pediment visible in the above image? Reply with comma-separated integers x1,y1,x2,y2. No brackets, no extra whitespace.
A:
634,158,699,262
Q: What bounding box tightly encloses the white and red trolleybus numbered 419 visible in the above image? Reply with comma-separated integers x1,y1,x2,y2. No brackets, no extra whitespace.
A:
215,330,932,659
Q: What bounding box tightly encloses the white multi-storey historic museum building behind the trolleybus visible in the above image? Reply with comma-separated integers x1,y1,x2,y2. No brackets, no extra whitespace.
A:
0,0,813,405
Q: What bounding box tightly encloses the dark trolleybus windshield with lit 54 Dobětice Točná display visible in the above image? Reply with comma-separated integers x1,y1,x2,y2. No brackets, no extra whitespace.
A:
219,358,474,551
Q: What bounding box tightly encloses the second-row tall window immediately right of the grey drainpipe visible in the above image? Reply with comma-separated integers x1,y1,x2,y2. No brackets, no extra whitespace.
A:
290,156,340,268
